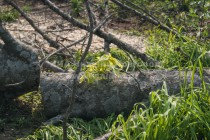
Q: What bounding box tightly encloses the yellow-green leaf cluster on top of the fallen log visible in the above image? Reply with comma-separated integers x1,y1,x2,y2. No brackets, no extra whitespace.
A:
80,54,123,83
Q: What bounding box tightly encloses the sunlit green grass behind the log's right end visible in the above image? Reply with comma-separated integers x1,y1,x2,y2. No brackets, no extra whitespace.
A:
147,29,210,68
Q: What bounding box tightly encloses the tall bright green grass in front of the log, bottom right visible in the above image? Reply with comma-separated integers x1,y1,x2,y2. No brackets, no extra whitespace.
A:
111,82,210,140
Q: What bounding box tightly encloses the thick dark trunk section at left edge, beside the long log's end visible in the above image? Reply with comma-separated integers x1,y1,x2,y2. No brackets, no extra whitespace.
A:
0,25,40,99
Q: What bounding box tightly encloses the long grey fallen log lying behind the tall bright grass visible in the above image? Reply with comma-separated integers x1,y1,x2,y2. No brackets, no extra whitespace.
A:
41,70,210,118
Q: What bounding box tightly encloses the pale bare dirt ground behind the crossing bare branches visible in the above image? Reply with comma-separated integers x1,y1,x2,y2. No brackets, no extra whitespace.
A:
6,2,145,53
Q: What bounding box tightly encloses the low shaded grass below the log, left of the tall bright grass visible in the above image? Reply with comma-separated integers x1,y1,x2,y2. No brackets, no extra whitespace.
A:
18,115,116,140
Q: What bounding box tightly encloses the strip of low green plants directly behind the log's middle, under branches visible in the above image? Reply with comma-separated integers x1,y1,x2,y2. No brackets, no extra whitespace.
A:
50,47,146,72
